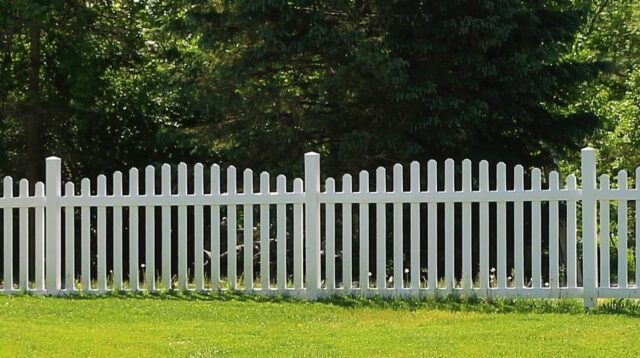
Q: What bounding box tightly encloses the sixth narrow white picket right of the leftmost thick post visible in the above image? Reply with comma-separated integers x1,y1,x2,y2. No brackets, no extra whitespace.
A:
144,165,156,292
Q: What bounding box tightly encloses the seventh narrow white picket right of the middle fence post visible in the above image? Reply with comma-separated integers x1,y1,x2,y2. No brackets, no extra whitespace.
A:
427,160,438,290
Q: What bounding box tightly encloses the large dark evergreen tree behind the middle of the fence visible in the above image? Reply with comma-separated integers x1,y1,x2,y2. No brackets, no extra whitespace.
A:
159,0,600,178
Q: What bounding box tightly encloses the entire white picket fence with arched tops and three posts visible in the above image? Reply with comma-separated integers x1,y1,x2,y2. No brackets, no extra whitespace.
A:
0,148,640,306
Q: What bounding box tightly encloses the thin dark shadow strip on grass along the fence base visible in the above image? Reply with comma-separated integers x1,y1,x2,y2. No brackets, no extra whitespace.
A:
11,291,640,317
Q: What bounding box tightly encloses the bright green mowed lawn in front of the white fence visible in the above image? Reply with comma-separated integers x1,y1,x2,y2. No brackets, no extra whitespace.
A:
0,294,640,357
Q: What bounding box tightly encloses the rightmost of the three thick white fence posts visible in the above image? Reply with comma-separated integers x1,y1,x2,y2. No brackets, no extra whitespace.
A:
581,147,598,308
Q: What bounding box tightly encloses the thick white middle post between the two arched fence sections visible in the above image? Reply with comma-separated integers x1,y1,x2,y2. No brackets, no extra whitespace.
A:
304,152,320,299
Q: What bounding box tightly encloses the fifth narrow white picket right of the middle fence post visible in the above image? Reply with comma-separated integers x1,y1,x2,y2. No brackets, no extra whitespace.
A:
393,164,404,290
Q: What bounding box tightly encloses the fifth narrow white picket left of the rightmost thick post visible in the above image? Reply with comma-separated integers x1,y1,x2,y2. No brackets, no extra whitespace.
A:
496,162,508,288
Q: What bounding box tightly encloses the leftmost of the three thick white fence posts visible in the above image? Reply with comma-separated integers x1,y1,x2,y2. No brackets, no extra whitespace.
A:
45,157,62,294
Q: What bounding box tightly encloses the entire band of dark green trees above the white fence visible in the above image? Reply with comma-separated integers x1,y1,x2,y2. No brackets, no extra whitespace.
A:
0,0,640,180
